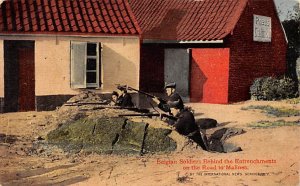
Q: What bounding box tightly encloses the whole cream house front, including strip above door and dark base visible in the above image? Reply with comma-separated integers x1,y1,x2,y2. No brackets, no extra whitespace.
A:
0,36,140,110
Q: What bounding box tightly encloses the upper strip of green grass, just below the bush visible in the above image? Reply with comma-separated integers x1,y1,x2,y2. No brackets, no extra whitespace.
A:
241,105,300,117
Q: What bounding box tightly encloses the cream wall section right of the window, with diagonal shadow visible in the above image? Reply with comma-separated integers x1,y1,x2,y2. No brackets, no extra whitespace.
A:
102,38,140,91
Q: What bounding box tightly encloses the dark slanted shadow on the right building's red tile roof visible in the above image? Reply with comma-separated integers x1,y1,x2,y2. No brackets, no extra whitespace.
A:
144,9,186,39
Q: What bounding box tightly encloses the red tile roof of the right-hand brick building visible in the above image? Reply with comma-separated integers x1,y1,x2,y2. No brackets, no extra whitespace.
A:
130,0,247,41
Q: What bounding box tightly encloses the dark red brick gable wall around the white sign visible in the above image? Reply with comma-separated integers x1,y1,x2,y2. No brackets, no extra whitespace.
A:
225,0,287,102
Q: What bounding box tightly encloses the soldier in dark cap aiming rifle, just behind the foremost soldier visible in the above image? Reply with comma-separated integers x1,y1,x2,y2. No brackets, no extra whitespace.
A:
153,83,184,113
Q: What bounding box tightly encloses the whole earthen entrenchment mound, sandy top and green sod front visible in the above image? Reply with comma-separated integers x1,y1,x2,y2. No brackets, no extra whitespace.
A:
46,92,244,154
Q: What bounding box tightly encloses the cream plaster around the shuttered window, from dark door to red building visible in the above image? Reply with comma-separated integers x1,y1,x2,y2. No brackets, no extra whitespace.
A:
36,35,139,95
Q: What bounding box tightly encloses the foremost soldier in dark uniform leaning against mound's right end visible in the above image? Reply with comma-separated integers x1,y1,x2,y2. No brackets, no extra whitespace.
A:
170,102,208,150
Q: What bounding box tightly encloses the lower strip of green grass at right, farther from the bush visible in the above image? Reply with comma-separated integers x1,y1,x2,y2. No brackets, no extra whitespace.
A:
248,120,300,128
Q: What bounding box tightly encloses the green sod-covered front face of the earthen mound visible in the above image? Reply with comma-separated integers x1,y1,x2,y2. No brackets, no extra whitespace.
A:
47,117,176,154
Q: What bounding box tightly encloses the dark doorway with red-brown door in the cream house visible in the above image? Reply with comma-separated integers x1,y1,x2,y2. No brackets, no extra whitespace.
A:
4,41,35,112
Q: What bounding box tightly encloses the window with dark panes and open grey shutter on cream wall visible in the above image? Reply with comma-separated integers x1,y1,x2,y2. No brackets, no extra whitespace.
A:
71,42,102,88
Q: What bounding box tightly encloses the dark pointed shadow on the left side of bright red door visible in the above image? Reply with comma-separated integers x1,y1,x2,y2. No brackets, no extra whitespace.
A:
190,59,207,102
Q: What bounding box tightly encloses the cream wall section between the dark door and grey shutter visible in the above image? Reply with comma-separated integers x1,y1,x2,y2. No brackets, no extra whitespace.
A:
35,38,76,96
